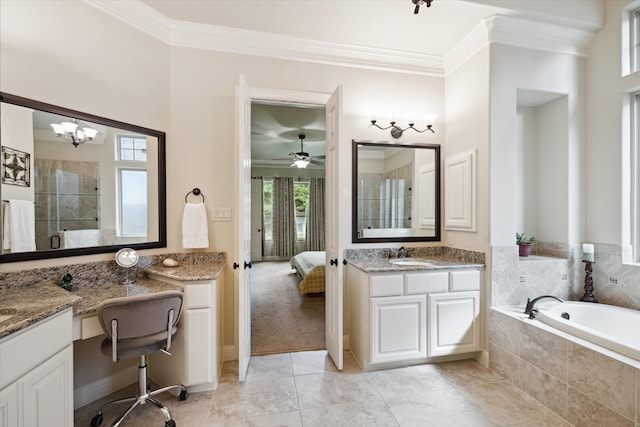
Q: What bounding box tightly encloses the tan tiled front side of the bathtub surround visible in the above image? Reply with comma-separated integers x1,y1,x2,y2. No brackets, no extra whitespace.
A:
488,309,640,426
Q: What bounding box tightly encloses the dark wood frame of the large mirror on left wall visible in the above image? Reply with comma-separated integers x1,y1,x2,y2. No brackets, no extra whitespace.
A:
0,92,167,263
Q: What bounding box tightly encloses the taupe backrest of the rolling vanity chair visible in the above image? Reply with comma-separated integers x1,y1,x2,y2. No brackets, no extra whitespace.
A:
97,291,183,356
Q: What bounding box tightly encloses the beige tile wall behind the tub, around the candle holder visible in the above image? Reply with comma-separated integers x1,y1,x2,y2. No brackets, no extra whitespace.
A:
491,242,640,309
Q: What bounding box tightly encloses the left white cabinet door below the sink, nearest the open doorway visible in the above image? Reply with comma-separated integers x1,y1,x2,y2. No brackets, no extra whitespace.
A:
371,295,427,363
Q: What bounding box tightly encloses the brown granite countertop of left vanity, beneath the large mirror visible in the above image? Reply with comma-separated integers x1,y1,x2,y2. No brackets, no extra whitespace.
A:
0,262,225,338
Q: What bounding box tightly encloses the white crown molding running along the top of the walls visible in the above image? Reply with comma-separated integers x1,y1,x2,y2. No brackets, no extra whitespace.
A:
83,0,592,77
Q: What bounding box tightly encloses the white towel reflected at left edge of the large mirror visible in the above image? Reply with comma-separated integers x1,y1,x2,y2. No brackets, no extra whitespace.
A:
2,200,36,253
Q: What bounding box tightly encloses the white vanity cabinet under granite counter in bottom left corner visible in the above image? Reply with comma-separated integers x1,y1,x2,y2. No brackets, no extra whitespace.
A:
0,308,73,427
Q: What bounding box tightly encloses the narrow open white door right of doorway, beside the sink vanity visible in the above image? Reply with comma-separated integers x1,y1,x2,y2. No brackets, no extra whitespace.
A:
325,86,350,370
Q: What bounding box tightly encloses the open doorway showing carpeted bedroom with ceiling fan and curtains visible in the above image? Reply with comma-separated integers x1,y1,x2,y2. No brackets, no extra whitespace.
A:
250,100,325,355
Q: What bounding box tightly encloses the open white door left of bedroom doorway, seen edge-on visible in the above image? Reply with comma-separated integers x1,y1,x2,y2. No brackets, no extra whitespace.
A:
233,75,251,381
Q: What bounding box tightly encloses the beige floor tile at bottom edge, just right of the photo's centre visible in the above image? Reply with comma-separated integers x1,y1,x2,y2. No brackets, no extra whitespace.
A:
301,401,398,427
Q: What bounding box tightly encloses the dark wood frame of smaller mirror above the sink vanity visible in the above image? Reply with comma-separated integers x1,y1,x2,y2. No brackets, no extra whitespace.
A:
351,140,441,243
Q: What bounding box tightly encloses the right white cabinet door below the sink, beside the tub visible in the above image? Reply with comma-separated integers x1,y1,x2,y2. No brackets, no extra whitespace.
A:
428,292,480,357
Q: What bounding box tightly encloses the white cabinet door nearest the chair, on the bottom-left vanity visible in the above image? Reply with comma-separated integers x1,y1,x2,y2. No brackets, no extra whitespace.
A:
18,346,73,427
